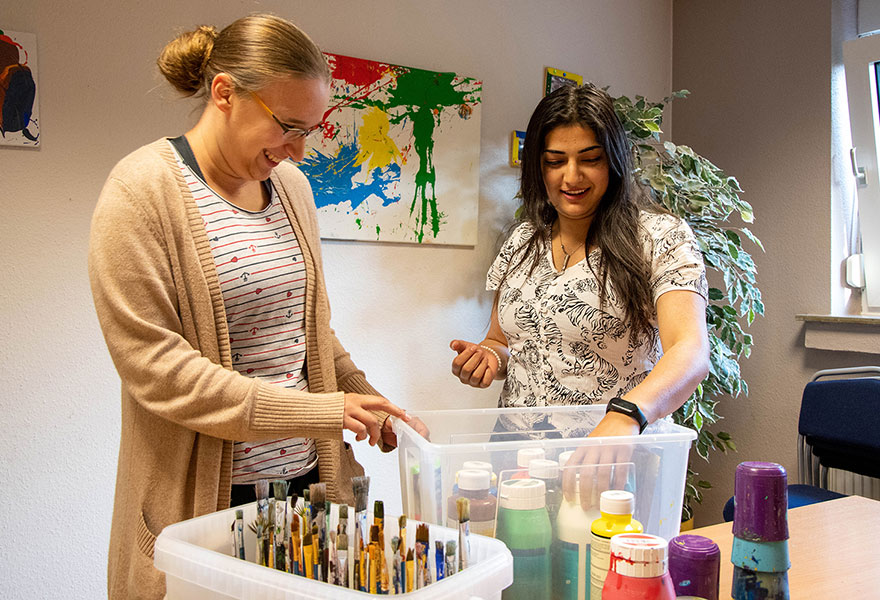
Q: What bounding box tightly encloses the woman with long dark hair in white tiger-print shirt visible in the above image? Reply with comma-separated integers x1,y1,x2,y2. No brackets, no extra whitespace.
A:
451,84,709,450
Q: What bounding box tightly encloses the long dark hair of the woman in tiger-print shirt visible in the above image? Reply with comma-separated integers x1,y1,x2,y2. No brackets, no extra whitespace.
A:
495,83,664,336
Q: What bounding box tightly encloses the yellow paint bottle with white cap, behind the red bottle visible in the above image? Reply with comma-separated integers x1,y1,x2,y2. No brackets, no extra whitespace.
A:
590,490,644,600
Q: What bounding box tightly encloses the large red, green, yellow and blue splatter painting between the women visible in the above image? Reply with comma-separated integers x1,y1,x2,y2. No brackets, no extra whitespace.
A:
300,54,482,245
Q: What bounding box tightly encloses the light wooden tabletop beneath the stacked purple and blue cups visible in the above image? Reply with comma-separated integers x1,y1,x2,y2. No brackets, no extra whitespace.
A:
683,496,880,600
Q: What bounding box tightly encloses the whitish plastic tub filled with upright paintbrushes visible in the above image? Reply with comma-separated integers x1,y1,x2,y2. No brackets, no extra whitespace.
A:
154,500,513,600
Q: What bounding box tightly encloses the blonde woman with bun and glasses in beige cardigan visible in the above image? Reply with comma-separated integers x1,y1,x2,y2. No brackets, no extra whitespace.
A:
89,15,420,598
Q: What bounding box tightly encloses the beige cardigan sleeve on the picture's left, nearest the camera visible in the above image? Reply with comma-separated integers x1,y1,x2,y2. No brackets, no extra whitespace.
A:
89,166,344,441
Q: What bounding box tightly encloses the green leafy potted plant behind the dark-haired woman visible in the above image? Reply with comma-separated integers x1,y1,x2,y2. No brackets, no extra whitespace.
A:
614,90,764,520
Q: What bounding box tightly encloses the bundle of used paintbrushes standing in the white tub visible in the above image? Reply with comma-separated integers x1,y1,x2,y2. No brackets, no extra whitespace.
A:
231,477,468,595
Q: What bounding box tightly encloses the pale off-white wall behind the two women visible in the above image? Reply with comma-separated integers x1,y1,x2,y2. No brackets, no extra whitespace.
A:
0,0,672,599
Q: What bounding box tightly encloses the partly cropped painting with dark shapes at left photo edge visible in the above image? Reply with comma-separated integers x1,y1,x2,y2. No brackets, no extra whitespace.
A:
0,29,40,146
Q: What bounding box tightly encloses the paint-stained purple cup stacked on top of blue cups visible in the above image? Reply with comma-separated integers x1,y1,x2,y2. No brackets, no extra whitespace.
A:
733,462,788,542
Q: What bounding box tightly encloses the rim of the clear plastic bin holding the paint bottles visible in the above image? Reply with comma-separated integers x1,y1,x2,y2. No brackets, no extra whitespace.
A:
391,404,697,452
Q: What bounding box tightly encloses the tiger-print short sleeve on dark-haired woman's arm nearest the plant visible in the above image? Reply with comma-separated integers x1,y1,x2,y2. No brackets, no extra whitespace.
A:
643,214,709,302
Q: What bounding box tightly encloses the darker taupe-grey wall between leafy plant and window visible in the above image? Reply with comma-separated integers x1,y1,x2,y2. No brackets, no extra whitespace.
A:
672,0,878,525
